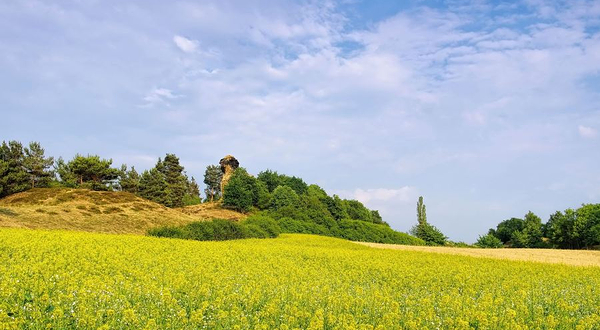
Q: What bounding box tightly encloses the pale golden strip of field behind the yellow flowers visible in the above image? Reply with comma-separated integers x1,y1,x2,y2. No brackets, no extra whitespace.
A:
356,242,600,267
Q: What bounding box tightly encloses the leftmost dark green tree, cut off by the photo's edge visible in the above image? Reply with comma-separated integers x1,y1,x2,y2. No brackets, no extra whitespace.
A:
0,141,31,197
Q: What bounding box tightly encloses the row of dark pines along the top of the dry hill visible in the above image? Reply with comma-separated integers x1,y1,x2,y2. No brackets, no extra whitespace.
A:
0,141,201,207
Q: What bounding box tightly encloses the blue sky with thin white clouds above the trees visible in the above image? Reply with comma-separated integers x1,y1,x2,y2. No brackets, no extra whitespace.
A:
0,0,600,242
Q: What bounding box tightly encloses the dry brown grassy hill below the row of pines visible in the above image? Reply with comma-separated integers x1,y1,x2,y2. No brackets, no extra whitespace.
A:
0,188,244,234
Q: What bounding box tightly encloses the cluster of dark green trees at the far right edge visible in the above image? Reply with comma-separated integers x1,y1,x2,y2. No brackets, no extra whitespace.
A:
476,204,600,249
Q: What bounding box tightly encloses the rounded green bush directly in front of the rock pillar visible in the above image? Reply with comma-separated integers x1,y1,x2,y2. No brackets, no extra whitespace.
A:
223,167,258,212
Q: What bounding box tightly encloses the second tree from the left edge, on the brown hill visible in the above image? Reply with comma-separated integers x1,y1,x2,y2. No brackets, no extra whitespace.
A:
23,142,54,188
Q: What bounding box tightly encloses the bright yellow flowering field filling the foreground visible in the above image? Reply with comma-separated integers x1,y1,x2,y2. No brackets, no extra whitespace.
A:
0,229,600,329
